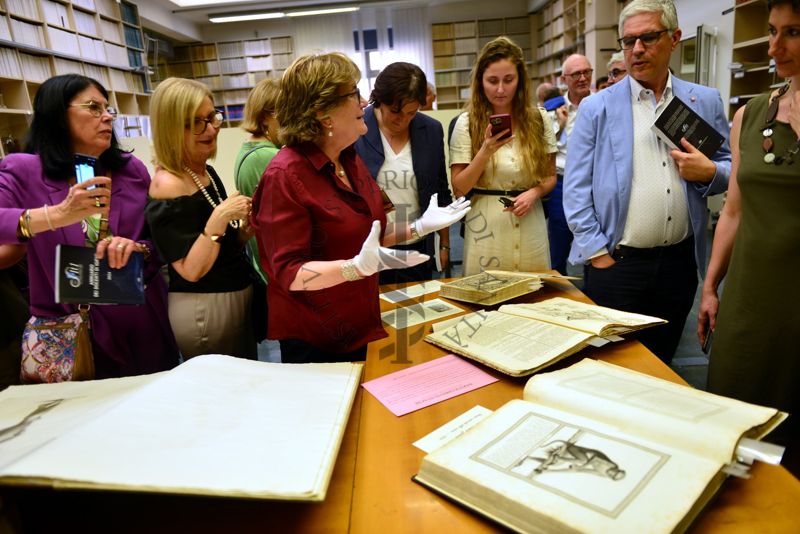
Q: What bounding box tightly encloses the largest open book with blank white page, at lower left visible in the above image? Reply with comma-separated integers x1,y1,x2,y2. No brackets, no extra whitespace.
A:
0,355,362,501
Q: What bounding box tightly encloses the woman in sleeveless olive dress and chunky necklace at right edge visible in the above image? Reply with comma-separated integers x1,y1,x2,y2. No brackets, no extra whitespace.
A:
697,0,800,462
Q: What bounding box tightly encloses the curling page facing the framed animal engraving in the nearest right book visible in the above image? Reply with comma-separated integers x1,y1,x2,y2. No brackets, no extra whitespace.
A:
523,360,779,464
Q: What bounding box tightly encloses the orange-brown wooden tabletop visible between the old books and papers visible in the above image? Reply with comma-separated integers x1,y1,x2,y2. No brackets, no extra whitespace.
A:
350,281,800,534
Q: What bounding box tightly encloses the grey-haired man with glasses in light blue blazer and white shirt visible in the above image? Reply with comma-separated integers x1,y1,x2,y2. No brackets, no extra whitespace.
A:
564,0,731,363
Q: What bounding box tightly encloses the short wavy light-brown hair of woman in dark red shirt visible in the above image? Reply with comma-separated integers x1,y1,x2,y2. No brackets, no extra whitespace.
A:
276,52,361,146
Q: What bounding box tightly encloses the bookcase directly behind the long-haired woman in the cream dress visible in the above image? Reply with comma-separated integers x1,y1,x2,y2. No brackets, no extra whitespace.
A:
431,15,532,109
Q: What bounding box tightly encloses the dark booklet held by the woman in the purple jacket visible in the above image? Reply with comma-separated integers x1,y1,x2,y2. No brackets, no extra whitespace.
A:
55,245,144,304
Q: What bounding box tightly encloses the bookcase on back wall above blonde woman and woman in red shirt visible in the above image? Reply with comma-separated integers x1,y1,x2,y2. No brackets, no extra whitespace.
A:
156,37,294,127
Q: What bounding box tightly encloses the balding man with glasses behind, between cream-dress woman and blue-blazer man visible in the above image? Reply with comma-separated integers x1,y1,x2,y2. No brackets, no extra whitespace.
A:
544,54,594,274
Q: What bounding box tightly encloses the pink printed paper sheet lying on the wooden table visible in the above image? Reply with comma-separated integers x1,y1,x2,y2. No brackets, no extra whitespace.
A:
362,354,497,416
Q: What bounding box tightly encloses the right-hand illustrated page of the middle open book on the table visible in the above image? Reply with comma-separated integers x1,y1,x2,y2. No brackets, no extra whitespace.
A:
500,297,666,336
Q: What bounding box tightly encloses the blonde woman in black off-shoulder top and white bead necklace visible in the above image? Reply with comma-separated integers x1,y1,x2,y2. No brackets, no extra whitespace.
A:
146,78,256,359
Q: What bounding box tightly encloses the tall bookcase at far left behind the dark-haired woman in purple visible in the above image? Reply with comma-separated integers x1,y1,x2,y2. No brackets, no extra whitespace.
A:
0,0,149,157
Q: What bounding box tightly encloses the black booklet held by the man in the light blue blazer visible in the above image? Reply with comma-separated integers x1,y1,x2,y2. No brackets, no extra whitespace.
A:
652,96,725,158
